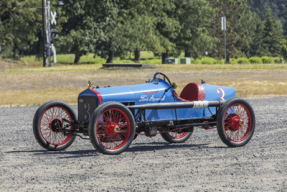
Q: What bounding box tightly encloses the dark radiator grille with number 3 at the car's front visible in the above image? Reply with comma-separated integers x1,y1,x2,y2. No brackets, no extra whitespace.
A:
78,97,98,123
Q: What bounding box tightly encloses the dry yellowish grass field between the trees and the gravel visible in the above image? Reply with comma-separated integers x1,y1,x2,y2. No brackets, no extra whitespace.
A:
0,58,287,106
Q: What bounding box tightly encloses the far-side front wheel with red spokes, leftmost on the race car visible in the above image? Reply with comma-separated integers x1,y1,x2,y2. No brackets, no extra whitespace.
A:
33,100,76,151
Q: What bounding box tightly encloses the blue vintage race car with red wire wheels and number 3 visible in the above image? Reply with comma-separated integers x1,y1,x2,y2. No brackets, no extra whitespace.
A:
33,72,255,154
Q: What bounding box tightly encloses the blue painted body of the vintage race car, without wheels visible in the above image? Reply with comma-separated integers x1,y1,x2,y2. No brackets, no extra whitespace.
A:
78,79,236,121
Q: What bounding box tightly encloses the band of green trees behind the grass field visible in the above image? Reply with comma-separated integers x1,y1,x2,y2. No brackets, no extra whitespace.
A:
0,0,287,63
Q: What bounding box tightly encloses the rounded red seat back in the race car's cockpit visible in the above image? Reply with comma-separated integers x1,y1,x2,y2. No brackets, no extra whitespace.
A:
180,83,205,101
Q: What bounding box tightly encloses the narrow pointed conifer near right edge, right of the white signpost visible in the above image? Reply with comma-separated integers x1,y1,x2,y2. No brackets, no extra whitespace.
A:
262,9,283,57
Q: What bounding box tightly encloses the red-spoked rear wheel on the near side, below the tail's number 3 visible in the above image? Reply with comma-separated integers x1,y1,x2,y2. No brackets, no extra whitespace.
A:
217,98,255,147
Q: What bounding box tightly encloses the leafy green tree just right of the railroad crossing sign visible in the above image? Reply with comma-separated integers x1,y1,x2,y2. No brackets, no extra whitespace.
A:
58,0,111,63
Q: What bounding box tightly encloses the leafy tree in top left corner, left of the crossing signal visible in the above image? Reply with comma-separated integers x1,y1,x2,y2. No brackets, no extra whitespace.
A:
0,0,41,59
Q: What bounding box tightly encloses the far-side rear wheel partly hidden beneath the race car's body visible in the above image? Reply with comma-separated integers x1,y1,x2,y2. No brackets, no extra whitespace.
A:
161,127,193,143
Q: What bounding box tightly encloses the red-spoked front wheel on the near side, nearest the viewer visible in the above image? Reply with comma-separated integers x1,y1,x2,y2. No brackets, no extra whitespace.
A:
88,102,135,155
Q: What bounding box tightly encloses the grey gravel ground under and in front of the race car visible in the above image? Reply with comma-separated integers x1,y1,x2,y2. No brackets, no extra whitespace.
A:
0,97,287,191
